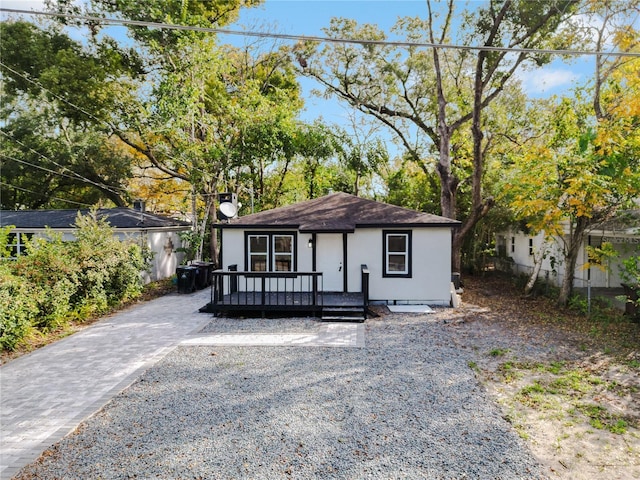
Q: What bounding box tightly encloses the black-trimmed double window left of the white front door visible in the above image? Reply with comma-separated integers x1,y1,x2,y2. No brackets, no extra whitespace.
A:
246,233,295,272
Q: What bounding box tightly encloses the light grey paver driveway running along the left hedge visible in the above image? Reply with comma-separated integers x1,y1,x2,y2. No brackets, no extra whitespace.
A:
0,289,211,479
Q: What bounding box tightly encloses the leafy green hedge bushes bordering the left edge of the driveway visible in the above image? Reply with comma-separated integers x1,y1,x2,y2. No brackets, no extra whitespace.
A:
0,211,148,350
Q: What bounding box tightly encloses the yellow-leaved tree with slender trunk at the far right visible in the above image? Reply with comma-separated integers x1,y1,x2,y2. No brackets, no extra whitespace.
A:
502,1,640,305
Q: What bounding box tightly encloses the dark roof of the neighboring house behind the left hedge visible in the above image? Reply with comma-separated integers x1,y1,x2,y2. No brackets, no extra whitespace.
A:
0,208,190,230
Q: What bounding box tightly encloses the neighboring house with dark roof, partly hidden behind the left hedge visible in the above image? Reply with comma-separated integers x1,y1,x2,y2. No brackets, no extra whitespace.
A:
0,208,191,283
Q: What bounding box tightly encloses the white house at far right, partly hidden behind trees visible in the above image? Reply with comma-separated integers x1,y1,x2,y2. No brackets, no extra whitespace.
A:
496,211,640,288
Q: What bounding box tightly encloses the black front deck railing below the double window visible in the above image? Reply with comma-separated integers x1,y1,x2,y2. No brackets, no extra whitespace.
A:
211,270,322,309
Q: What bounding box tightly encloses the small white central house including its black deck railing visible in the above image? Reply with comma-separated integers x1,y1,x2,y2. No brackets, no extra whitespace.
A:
208,193,459,315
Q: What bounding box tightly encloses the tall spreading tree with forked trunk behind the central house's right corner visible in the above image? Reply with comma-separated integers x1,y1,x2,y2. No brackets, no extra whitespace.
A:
296,0,577,269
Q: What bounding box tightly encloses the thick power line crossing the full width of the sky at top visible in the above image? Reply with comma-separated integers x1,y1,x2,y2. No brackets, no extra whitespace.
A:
5,7,640,58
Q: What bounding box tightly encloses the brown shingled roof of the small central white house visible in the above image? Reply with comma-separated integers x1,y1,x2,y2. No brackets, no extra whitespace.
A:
221,192,460,232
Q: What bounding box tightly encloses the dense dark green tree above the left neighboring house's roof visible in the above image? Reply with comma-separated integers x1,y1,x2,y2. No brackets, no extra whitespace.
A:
0,21,136,208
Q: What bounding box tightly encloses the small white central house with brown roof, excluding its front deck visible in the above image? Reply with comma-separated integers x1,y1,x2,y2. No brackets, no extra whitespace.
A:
219,193,459,305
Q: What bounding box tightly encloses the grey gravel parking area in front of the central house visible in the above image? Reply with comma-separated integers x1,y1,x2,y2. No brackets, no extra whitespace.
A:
16,309,546,479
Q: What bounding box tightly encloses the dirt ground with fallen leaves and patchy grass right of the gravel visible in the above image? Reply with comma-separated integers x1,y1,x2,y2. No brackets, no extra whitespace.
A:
444,277,640,480
